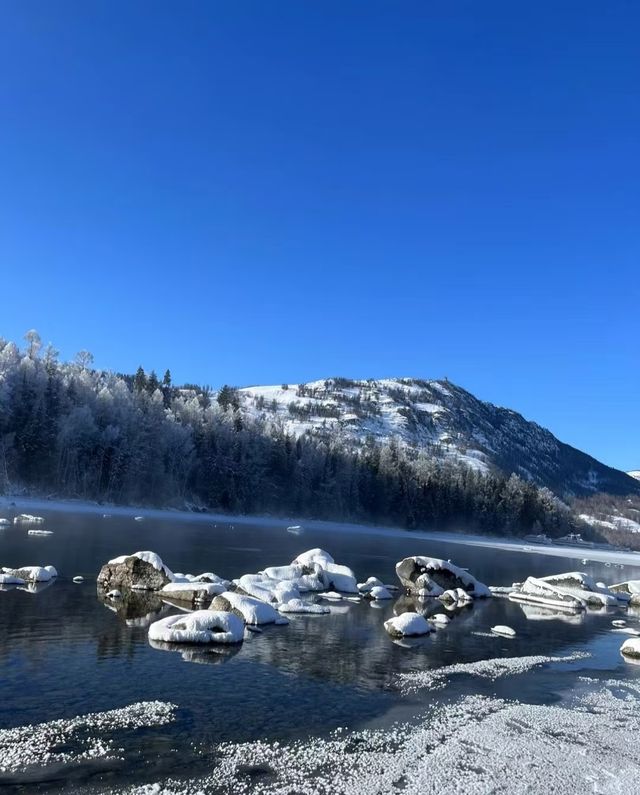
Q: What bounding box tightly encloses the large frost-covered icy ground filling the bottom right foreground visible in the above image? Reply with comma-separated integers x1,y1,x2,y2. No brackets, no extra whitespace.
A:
122,679,640,795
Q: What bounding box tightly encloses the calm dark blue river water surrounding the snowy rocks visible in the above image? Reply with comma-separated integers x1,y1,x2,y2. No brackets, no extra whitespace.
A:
0,501,640,791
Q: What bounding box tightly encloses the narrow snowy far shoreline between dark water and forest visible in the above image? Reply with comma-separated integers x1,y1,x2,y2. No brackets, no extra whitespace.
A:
5,495,640,567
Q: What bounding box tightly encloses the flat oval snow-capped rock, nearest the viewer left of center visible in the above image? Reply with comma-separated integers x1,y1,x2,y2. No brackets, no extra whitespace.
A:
149,610,244,643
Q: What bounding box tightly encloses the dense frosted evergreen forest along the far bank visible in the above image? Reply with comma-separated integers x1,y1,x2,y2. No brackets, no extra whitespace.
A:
0,332,584,536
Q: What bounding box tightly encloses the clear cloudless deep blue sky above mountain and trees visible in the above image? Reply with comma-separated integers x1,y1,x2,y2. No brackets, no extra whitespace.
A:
0,0,640,469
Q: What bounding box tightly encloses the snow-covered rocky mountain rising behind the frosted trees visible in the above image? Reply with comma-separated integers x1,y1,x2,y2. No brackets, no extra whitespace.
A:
237,378,640,495
